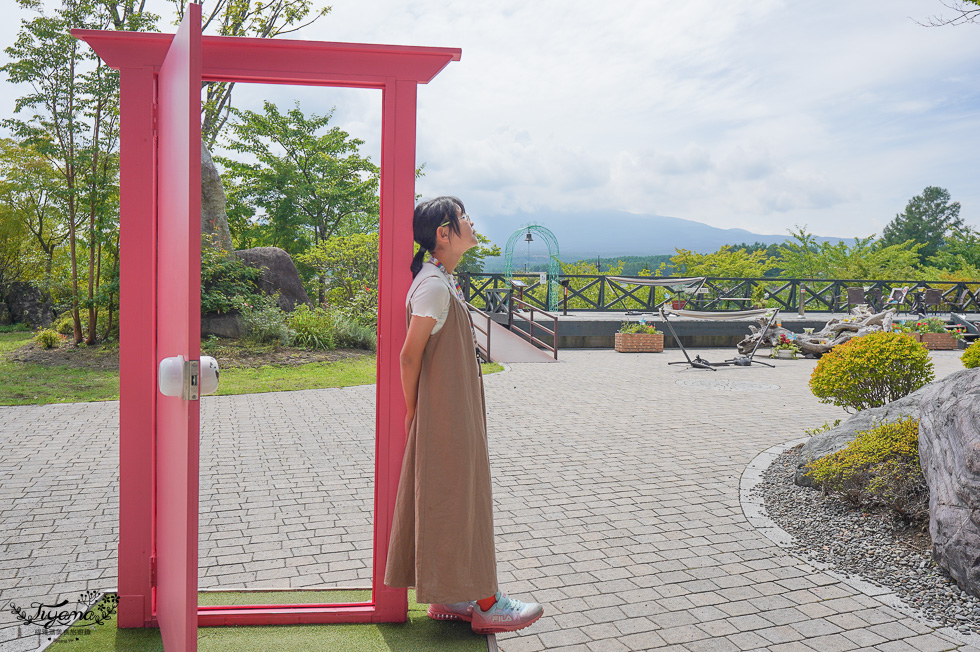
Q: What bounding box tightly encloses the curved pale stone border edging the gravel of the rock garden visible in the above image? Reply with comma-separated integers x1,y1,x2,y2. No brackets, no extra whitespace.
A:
738,437,980,648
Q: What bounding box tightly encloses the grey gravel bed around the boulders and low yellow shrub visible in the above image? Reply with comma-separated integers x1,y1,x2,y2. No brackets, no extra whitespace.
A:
753,446,980,634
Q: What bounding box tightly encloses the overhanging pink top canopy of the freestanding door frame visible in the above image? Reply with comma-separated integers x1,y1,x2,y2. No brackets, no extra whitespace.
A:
71,29,462,88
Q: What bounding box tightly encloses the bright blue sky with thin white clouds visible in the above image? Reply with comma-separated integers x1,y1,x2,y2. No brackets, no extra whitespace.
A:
0,0,980,238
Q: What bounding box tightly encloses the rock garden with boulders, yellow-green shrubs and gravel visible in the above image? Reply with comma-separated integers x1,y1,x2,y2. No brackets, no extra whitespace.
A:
754,330,980,633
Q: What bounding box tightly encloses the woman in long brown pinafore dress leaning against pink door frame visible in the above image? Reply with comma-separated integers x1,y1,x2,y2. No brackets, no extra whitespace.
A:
385,197,544,634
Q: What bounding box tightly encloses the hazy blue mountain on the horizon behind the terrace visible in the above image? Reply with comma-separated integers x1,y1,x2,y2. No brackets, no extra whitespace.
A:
474,211,842,263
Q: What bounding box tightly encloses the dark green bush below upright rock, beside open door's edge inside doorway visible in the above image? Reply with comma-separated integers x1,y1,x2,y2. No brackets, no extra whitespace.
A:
201,235,263,315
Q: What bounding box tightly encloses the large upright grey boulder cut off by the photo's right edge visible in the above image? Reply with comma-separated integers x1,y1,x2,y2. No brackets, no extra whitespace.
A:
919,369,980,596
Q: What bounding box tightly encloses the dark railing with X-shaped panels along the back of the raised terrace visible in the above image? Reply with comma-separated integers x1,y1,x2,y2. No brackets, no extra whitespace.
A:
459,272,980,312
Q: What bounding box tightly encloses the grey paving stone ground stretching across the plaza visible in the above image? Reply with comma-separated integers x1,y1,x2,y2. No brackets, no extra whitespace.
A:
0,349,978,652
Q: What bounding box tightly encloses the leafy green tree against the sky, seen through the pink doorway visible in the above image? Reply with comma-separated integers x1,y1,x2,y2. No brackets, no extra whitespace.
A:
214,101,379,262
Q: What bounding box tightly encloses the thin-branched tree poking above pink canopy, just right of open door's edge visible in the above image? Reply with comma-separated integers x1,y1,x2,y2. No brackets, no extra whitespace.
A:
167,0,331,150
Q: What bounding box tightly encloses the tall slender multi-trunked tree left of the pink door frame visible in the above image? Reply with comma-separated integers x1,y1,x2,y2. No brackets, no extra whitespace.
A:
0,0,133,344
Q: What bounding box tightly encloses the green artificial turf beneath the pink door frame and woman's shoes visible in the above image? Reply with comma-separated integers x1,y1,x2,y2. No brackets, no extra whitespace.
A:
48,590,487,652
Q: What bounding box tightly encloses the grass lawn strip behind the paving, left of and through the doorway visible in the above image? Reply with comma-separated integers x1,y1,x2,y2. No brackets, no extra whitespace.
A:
0,331,503,405
